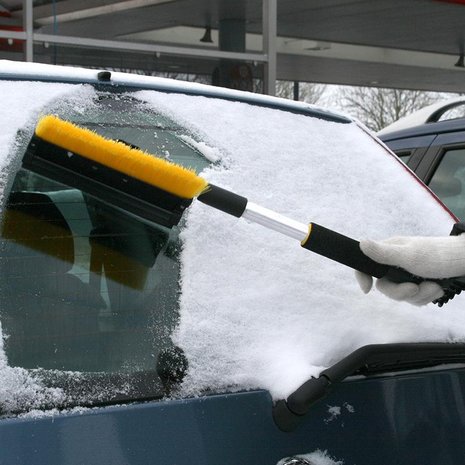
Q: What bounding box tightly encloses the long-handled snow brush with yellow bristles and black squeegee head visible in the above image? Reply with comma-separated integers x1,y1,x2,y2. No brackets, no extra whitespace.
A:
23,115,465,306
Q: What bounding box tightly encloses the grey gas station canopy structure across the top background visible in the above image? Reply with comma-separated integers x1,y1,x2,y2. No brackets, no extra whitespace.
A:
0,0,465,93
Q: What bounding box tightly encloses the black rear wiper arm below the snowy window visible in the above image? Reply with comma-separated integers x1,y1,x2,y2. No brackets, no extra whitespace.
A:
273,342,465,431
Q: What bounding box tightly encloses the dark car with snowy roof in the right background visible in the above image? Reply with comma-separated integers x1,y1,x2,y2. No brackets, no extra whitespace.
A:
378,97,465,220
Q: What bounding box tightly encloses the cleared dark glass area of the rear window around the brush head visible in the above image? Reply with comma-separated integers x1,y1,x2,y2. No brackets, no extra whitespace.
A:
0,93,209,414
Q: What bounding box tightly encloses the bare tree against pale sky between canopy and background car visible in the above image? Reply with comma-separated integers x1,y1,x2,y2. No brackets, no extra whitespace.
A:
338,87,441,131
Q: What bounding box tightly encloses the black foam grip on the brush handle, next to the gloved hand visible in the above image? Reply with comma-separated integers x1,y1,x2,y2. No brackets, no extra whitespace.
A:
302,223,391,278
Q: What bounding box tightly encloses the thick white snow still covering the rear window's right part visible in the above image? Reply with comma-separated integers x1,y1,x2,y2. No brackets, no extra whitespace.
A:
140,92,465,399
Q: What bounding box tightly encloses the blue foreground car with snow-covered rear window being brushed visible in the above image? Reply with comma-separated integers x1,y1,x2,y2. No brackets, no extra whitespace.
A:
0,61,465,465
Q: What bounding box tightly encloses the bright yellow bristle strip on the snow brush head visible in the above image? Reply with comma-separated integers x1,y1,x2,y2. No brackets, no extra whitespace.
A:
35,115,208,199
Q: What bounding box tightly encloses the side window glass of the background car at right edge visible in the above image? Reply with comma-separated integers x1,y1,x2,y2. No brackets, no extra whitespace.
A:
429,148,465,220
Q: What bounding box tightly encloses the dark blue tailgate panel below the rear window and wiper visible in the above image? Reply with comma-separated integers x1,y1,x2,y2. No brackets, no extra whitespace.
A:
0,368,465,465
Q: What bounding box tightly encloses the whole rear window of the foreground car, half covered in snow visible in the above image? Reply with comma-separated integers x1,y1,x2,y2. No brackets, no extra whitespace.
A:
0,78,456,415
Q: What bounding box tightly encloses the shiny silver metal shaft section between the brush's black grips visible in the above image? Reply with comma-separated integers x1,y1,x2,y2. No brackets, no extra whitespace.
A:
242,202,308,241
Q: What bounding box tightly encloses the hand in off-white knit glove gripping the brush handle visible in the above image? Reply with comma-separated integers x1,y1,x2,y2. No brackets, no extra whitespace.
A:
356,234,465,305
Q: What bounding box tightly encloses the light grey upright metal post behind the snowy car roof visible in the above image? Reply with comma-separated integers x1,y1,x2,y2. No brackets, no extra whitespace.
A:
262,0,278,95
